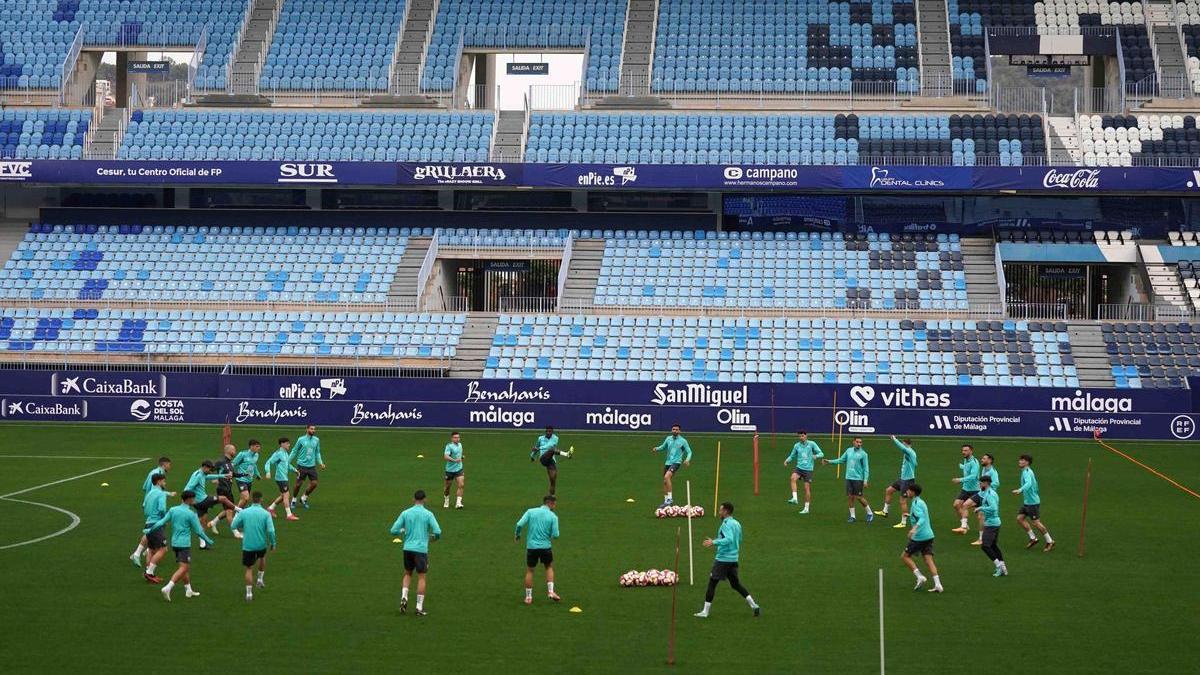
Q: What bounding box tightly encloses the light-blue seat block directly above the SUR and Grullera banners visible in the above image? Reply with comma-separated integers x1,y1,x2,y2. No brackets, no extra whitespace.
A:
119,110,494,162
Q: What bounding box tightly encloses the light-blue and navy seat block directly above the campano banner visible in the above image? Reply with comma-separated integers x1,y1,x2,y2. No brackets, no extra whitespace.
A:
526,113,1045,166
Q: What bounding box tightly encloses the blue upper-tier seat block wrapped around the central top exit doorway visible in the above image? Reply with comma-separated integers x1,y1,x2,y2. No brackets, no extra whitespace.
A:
421,0,626,91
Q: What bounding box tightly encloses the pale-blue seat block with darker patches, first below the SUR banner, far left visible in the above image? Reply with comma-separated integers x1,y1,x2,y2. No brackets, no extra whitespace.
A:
0,225,409,303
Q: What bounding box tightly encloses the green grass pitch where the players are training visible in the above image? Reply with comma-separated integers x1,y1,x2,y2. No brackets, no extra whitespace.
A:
0,424,1200,673
